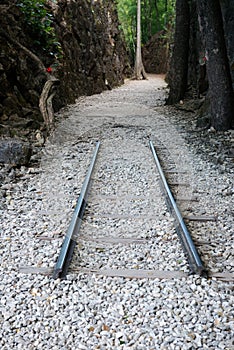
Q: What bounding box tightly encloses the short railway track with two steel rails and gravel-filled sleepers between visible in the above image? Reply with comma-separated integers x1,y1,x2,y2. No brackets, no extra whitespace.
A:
53,141,205,279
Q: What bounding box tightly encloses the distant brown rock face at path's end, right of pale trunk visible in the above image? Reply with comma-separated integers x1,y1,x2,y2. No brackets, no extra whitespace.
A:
142,31,168,74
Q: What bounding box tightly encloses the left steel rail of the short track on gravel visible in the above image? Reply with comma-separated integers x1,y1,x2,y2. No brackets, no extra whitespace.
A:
53,141,100,279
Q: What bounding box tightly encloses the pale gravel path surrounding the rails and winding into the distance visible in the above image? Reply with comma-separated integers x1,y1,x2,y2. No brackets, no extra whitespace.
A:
0,76,234,350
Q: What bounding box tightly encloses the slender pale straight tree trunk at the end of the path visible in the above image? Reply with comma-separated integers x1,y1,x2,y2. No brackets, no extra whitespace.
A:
135,0,147,80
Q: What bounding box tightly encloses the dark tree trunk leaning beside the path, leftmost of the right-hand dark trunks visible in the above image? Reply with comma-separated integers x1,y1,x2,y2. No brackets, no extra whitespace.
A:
167,0,189,104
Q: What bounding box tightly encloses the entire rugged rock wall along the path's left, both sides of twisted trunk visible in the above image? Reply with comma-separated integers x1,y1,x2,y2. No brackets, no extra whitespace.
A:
0,0,128,141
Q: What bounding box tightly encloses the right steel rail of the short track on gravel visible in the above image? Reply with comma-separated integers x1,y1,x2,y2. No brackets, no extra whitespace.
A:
149,141,205,275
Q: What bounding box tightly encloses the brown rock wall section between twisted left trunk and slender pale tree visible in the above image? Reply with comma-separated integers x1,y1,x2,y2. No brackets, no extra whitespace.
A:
55,0,129,102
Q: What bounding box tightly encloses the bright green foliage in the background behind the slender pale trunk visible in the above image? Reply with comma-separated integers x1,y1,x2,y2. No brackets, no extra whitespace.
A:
117,0,175,56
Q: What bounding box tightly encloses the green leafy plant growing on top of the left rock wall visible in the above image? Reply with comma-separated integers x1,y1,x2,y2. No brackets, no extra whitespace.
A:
17,0,60,55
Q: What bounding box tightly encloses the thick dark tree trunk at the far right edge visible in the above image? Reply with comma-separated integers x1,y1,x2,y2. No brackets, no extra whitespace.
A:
197,0,234,130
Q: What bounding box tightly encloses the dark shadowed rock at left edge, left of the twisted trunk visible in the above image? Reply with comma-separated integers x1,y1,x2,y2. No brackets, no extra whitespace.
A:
0,1,47,136
